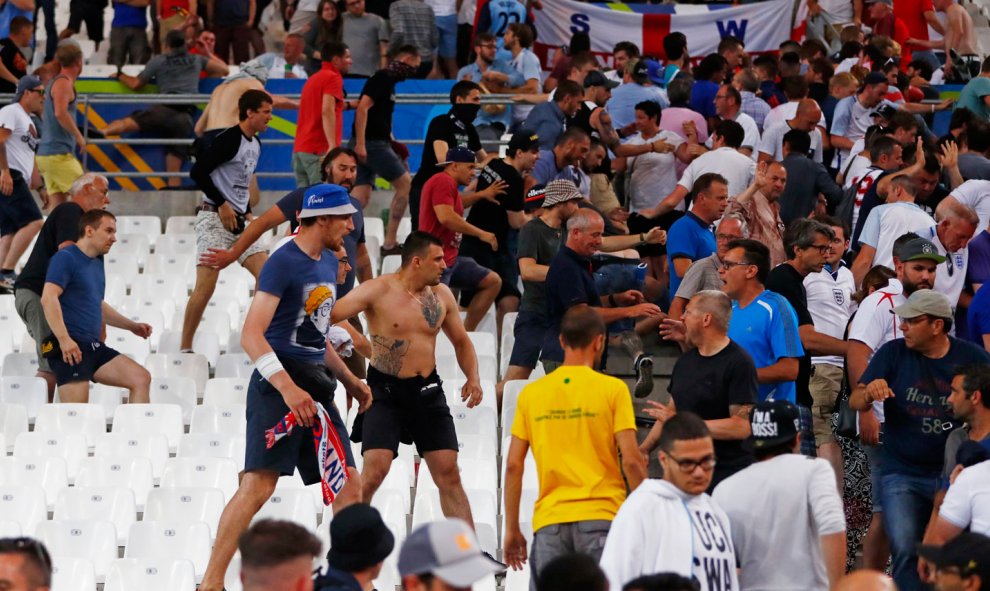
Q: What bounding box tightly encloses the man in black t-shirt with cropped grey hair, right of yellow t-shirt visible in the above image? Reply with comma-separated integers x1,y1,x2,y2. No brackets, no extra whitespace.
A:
640,290,757,492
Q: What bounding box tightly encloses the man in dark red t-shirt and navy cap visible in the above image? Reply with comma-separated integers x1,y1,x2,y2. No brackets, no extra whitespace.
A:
419,148,502,332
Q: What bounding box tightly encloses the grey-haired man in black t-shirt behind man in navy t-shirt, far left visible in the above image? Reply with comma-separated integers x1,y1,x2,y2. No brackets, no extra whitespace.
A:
14,172,110,398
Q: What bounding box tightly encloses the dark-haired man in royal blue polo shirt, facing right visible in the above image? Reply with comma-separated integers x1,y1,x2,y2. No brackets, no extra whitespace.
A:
667,172,729,298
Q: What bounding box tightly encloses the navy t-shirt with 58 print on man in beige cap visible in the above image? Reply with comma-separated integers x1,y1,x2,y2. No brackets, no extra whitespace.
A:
859,337,990,478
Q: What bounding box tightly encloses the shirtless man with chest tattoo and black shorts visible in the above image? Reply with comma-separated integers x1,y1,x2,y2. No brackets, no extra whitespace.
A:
330,232,481,524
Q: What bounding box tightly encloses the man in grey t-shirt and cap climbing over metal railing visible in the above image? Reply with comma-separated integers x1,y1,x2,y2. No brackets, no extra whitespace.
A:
100,30,227,187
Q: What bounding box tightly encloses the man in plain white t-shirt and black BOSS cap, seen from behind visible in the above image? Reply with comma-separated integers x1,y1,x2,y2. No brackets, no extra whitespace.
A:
712,400,846,591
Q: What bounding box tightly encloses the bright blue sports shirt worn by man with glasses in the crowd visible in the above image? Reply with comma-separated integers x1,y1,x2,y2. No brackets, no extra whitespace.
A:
729,290,804,403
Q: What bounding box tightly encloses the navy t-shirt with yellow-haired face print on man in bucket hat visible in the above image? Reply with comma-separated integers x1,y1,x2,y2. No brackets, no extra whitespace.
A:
258,240,337,362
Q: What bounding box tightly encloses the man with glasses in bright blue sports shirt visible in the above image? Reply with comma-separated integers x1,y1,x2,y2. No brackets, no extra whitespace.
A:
719,240,804,403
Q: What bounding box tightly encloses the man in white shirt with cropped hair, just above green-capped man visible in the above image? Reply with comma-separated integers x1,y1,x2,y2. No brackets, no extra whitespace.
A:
852,175,935,285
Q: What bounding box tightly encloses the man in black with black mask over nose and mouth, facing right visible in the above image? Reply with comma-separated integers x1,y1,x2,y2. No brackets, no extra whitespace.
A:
409,80,491,231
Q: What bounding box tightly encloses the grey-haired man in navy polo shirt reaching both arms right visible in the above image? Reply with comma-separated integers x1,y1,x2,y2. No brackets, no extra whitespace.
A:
540,209,660,374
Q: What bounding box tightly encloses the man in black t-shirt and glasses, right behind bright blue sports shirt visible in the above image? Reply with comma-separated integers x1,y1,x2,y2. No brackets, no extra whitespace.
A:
765,218,847,456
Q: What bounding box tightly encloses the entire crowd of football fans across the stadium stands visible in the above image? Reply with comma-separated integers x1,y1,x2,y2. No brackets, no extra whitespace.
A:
0,0,990,591
